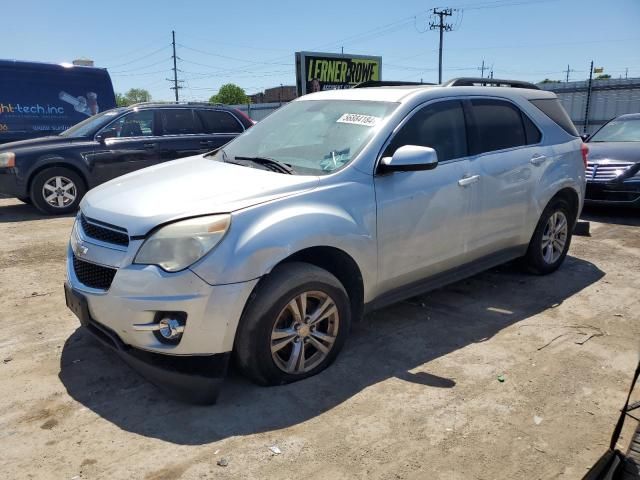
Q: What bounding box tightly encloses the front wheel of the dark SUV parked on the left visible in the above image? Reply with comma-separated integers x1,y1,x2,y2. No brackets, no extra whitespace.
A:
30,167,87,215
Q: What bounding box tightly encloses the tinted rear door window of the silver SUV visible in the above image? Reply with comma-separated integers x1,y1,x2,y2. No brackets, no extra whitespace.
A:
471,99,527,153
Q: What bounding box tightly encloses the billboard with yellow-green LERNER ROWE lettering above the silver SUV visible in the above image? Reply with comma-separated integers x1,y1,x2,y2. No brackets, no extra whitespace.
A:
296,52,382,95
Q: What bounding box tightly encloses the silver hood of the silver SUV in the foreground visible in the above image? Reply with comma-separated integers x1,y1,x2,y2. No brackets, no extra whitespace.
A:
80,155,319,235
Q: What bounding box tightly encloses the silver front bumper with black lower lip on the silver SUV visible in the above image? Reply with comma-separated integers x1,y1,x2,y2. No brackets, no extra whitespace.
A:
65,222,258,403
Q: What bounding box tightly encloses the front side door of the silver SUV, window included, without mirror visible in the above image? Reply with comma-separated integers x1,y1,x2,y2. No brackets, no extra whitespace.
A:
375,100,470,293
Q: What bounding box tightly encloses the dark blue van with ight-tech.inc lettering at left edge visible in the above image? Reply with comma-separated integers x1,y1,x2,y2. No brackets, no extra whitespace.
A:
0,60,116,143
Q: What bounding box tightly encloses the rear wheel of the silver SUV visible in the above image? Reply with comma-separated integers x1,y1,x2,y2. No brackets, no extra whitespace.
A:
522,198,575,275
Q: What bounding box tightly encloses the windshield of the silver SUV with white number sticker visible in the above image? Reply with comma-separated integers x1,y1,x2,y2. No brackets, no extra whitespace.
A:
213,100,398,175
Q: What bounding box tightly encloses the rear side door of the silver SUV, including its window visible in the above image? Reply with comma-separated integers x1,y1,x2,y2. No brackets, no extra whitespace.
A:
465,98,547,260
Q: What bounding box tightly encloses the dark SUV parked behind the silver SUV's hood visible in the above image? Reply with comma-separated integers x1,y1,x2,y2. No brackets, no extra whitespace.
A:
0,103,253,214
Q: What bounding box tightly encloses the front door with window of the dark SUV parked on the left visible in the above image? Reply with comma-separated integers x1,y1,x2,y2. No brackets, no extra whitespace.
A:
91,110,159,183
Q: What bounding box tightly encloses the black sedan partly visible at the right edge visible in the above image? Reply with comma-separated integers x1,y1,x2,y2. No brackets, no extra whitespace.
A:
585,113,640,207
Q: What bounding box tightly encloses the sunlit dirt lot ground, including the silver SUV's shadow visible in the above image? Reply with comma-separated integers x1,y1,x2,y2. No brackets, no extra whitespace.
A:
0,199,640,479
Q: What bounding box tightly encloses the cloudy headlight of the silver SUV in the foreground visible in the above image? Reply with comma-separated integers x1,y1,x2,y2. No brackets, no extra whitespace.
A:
134,215,231,272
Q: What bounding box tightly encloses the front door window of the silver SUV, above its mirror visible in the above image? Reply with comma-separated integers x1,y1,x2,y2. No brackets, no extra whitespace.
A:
383,101,468,162
